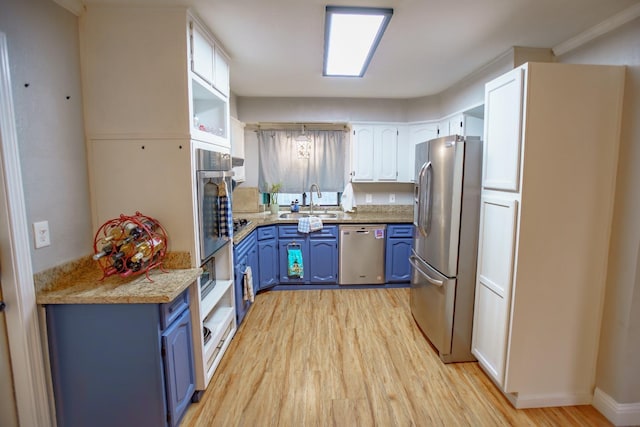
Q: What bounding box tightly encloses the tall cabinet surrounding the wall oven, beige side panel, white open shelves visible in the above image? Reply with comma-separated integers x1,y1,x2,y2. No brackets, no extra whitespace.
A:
80,4,236,390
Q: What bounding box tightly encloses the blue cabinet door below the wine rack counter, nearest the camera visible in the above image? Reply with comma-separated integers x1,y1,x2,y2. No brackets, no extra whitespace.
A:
162,310,195,426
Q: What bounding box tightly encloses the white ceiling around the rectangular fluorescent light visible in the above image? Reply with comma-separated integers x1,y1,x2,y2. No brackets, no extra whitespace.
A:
84,0,640,98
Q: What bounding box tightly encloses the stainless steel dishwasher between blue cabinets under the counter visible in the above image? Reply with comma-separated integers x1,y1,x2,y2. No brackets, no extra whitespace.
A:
338,224,387,285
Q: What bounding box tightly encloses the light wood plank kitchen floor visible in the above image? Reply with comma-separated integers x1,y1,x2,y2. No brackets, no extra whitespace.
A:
181,288,611,427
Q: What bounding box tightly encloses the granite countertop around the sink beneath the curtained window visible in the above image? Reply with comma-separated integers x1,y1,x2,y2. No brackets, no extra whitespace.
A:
233,206,413,244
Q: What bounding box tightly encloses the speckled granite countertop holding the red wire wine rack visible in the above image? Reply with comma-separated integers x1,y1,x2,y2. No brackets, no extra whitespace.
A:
36,257,202,304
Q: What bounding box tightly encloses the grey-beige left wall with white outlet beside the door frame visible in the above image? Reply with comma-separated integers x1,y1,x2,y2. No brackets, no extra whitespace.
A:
0,0,93,273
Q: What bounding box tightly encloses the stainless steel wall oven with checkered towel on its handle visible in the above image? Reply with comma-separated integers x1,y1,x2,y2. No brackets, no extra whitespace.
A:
196,149,233,264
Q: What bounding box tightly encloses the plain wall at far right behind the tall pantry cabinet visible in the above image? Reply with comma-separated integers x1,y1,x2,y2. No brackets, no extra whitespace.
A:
558,19,640,403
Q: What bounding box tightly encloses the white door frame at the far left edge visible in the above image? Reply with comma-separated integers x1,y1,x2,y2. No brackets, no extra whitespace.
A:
0,32,55,426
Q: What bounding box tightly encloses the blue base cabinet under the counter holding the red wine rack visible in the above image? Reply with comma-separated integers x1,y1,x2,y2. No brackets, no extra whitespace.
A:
45,291,195,427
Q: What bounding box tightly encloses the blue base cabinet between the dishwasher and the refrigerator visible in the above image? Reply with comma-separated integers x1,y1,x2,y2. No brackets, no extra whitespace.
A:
385,224,413,283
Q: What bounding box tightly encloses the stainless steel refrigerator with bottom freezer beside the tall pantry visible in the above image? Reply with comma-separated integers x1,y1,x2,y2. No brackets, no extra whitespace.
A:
410,135,482,363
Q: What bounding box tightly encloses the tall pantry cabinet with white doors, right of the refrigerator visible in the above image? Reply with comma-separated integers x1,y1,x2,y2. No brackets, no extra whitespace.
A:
472,63,624,408
